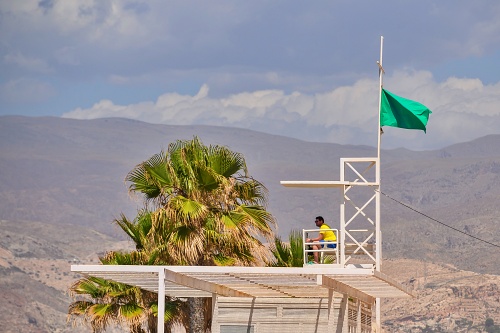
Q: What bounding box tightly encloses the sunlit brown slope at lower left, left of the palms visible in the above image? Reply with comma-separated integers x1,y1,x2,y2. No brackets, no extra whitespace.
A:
0,220,133,333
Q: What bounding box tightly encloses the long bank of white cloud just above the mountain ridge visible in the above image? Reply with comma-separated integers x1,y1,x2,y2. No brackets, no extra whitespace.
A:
63,71,500,149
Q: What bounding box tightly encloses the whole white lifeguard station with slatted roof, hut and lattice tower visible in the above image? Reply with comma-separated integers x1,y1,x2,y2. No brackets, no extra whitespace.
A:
71,40,412,333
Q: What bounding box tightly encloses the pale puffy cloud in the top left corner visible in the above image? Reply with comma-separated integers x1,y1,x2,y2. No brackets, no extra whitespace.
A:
0,0,149,49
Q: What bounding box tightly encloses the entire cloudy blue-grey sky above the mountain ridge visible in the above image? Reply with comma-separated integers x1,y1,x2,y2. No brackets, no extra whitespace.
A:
0,0,500,150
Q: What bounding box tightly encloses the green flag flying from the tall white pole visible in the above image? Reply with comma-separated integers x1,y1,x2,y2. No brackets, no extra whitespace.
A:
380,89,432,132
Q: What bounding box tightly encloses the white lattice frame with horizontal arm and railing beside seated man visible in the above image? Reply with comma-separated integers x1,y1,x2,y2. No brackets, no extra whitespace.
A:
281,157,382,270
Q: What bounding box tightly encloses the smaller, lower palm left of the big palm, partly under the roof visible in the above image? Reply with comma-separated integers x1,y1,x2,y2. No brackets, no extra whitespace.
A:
68,210,188,333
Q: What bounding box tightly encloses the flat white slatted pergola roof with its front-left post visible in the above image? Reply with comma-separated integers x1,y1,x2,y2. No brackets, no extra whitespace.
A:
71,265,413,333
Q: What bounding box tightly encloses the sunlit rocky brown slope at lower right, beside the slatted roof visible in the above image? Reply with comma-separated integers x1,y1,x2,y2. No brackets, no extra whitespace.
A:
381,259,500,333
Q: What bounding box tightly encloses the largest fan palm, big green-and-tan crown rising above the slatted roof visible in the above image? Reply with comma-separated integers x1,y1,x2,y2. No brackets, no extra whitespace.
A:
126,137,274,332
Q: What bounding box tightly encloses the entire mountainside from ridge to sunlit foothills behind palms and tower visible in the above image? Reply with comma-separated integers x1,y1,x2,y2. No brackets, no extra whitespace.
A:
0,116,500,332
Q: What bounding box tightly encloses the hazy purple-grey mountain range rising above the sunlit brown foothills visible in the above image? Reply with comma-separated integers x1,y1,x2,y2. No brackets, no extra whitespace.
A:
0,116,500,332
